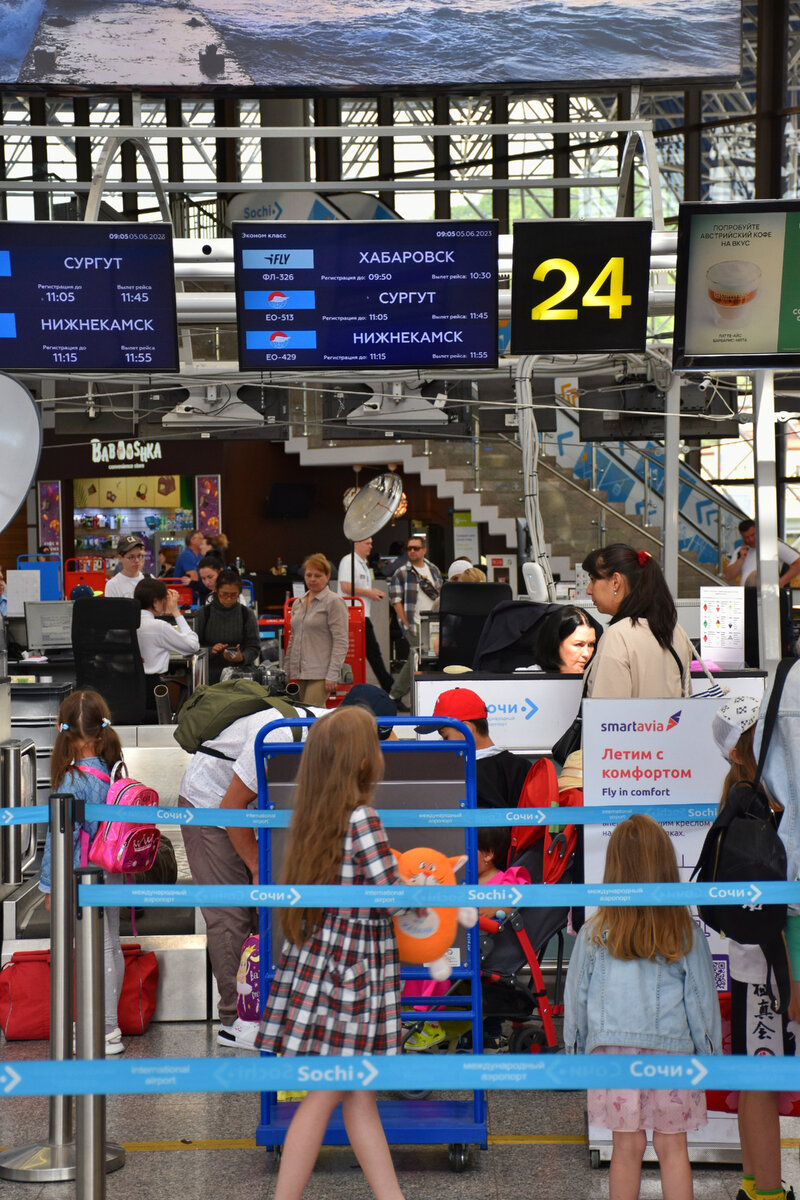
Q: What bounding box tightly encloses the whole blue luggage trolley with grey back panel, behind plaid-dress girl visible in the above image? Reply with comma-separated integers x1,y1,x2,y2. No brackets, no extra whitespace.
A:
255,716,487,1171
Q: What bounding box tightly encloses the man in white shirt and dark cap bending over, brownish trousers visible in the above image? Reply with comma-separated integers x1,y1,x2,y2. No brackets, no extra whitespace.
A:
179,684,397,1050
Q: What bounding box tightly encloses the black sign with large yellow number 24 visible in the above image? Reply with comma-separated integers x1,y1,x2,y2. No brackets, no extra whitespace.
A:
511,218,651,354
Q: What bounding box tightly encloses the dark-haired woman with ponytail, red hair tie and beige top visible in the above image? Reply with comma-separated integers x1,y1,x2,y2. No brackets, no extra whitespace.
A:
583,542,694,700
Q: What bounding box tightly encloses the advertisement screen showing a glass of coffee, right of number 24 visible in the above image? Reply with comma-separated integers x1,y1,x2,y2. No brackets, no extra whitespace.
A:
673,200,800,371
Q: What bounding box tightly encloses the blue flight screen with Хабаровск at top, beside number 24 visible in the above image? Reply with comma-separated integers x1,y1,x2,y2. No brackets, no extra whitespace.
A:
234,221,498,371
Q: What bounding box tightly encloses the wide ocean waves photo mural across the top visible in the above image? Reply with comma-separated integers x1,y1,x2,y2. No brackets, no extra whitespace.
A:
0,0,741,95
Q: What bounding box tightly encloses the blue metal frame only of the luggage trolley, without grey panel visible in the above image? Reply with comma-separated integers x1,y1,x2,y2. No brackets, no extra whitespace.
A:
255,716,487,1171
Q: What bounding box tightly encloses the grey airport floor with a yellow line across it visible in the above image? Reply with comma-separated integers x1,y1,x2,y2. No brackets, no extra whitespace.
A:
0,1022,800,1200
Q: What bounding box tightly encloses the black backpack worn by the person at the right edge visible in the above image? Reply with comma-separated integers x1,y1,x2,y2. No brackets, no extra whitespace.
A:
692,659,793,1013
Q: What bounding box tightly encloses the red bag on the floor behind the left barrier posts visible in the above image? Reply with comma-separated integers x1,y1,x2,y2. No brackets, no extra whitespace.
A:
0,942,158,1042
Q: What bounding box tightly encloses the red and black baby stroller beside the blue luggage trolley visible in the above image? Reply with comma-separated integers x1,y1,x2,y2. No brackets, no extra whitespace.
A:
404,758,583,1054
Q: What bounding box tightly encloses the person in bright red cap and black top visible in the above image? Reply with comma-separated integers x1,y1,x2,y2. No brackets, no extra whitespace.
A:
416,688,530,809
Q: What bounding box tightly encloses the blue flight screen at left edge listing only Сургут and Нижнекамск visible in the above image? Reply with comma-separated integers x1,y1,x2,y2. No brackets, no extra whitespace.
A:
0,221,179,371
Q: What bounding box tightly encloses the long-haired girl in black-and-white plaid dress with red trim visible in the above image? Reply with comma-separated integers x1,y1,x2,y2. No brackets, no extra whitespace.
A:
255,706,402,1200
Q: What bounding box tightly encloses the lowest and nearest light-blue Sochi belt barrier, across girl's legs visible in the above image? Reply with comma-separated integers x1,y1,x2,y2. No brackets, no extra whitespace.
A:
0,1054,800,1096
